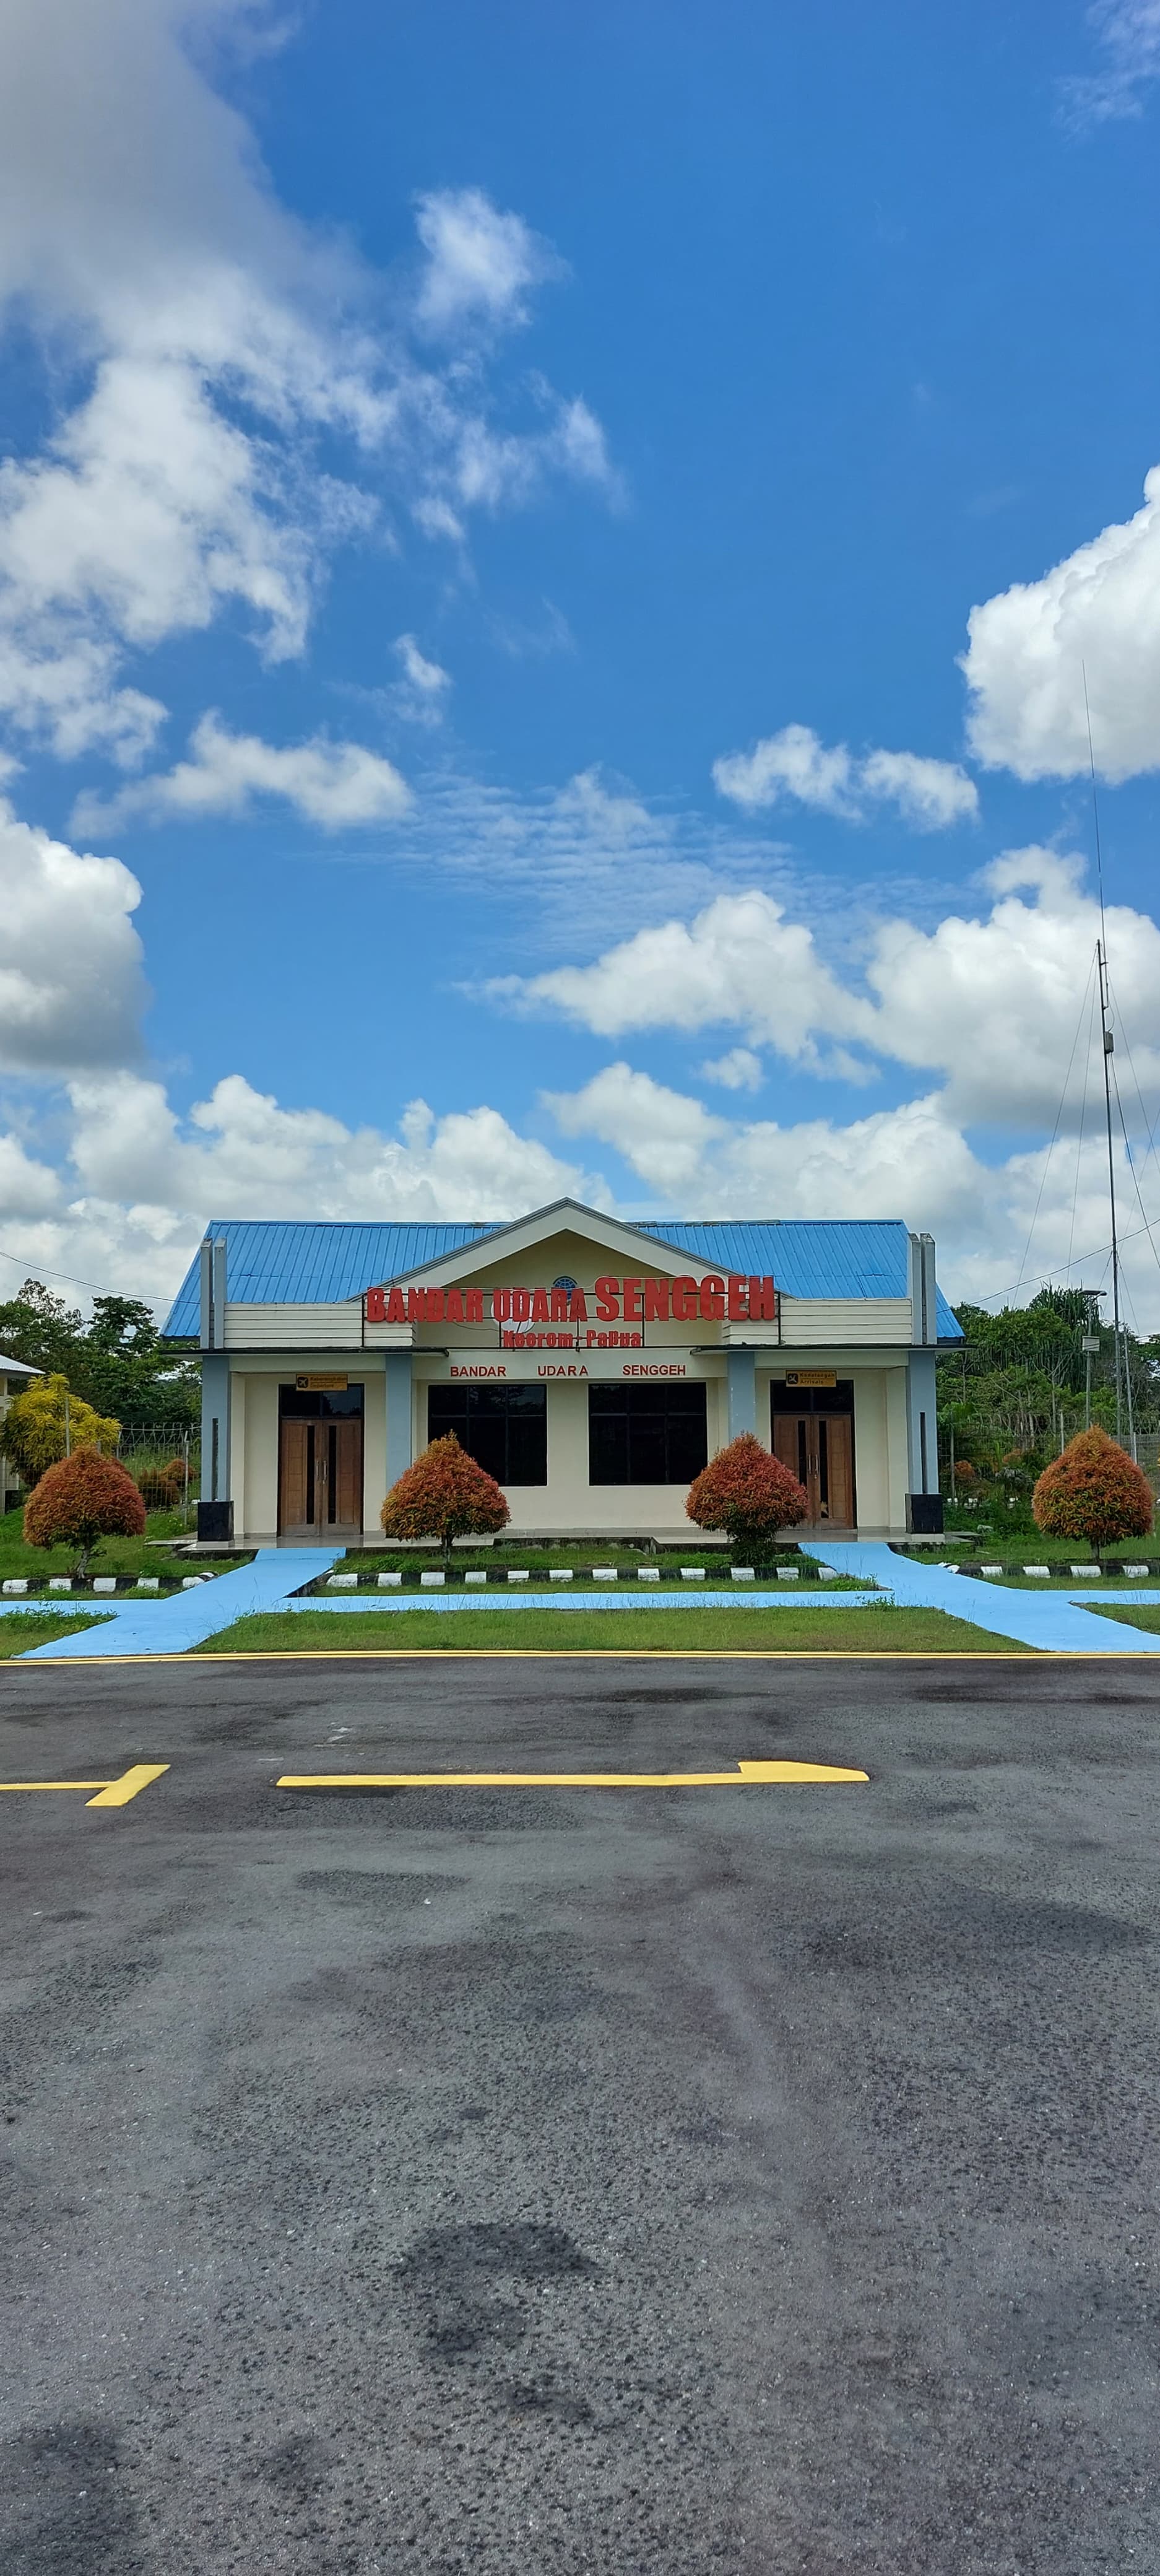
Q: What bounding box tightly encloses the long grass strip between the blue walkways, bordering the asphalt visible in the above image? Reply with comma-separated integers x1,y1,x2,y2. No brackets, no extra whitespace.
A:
193,1608,1034,1654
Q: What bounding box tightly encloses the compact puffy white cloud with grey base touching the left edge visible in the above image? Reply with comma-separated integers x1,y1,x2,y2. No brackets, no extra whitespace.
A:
0,804,144,1074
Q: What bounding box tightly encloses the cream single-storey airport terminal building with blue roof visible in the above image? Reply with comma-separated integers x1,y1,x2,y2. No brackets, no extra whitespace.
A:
165,1201,961,1546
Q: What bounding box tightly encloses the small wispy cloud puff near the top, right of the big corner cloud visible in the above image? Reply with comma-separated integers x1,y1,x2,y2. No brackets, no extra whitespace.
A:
415,188,567,333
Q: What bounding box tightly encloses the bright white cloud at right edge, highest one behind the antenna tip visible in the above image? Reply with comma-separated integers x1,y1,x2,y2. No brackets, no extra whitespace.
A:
961,466,1160,780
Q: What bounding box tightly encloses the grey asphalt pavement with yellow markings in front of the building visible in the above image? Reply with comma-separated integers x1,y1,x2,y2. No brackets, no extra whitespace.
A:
0,1659,1160,2576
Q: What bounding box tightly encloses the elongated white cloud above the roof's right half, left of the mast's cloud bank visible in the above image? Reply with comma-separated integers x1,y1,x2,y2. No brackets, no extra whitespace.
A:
490,891,874,1064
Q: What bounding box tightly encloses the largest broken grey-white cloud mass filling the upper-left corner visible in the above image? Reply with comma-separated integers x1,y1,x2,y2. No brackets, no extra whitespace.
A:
0,0,613,768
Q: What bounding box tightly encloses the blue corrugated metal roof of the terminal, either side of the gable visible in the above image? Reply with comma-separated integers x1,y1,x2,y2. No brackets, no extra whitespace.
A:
165,1216,961,1342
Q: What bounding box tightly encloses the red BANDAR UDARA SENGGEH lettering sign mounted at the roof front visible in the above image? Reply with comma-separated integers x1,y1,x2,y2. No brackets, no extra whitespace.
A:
363,1270,779,1347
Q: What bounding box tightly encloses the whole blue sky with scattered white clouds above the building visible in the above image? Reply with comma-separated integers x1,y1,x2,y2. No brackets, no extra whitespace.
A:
0,0,1160,1326
